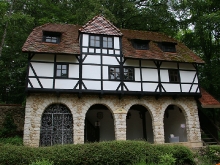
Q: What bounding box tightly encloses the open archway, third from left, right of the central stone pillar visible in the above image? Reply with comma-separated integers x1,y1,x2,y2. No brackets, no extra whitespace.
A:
126,105,154,143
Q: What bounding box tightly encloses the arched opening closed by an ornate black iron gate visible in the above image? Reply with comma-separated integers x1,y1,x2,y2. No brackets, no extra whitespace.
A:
40,104,73,146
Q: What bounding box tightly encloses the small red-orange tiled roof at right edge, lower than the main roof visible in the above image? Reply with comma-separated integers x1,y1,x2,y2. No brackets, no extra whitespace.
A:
199,89,220,108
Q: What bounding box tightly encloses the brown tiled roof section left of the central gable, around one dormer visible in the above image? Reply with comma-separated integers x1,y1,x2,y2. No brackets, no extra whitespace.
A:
22,23,81,54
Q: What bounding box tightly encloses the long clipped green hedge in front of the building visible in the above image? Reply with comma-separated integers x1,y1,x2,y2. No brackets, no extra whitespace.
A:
0,141,194,165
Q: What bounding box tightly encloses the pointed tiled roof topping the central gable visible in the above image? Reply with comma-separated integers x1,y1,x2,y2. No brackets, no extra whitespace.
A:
79,16,122,36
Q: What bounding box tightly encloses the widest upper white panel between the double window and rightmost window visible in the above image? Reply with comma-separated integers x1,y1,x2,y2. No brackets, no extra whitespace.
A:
142,68,158,82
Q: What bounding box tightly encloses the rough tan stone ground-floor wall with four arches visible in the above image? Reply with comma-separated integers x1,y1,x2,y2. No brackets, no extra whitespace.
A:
24,94,201,147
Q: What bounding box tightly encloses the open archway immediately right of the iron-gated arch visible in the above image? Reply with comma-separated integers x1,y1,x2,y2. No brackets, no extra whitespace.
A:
84,104,115,142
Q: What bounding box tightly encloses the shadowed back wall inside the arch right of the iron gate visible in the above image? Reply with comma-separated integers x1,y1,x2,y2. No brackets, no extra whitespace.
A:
86,110,115,141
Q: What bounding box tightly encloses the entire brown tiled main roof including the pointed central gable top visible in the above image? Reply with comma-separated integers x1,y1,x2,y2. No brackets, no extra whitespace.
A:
22,16,204,63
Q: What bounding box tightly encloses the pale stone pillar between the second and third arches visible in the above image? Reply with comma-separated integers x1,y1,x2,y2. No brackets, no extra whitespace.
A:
114,109,127,140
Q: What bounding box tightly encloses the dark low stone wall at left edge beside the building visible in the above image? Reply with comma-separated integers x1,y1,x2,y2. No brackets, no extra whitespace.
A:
0,105,25,132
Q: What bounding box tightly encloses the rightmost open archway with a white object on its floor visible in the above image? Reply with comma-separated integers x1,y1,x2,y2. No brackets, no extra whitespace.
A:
164,105,187,143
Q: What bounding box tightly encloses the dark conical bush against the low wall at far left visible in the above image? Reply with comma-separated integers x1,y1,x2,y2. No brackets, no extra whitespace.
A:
0,113,17,137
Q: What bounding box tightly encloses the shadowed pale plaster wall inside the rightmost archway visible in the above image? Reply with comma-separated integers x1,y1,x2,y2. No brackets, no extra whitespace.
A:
164,106,187,143
